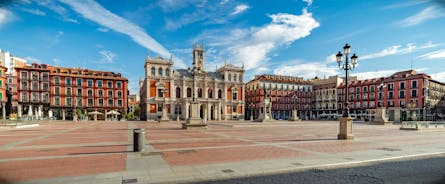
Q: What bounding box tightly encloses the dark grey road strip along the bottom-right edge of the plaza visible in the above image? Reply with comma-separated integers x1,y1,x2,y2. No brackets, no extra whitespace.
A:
199,155,445,184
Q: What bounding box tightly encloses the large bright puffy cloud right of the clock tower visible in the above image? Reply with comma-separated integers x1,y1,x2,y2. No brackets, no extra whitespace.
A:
229,9,320,70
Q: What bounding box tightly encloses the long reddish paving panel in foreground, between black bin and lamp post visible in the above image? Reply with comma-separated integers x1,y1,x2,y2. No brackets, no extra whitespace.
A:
163,146,307,166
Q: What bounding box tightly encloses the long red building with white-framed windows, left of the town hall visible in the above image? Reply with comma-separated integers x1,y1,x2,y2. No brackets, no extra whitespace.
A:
13,63,128,120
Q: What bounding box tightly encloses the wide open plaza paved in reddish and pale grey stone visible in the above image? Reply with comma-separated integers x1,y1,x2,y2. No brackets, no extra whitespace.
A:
0,121,445,184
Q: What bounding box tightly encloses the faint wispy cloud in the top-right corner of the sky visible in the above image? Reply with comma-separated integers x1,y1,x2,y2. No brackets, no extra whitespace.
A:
397,6,445,27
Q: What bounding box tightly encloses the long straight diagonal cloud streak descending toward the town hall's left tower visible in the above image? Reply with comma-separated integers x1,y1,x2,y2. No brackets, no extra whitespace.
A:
61,0,185,68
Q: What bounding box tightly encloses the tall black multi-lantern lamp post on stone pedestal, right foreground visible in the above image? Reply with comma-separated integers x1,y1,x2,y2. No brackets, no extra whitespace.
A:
336,44,358,139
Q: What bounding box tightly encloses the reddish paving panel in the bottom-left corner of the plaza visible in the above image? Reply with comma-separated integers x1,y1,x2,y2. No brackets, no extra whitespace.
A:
0,154,126,182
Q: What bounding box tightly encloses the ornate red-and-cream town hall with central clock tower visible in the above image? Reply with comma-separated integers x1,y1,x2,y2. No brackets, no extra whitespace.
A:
140,45,245,121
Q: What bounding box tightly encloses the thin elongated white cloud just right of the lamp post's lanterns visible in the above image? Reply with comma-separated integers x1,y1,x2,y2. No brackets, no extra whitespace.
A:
359,42,440,60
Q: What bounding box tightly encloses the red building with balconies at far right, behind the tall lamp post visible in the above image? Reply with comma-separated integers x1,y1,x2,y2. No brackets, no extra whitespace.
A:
338,70,438,122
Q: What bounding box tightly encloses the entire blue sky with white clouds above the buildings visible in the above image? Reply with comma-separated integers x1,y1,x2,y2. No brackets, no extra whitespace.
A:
0,0,445,93
